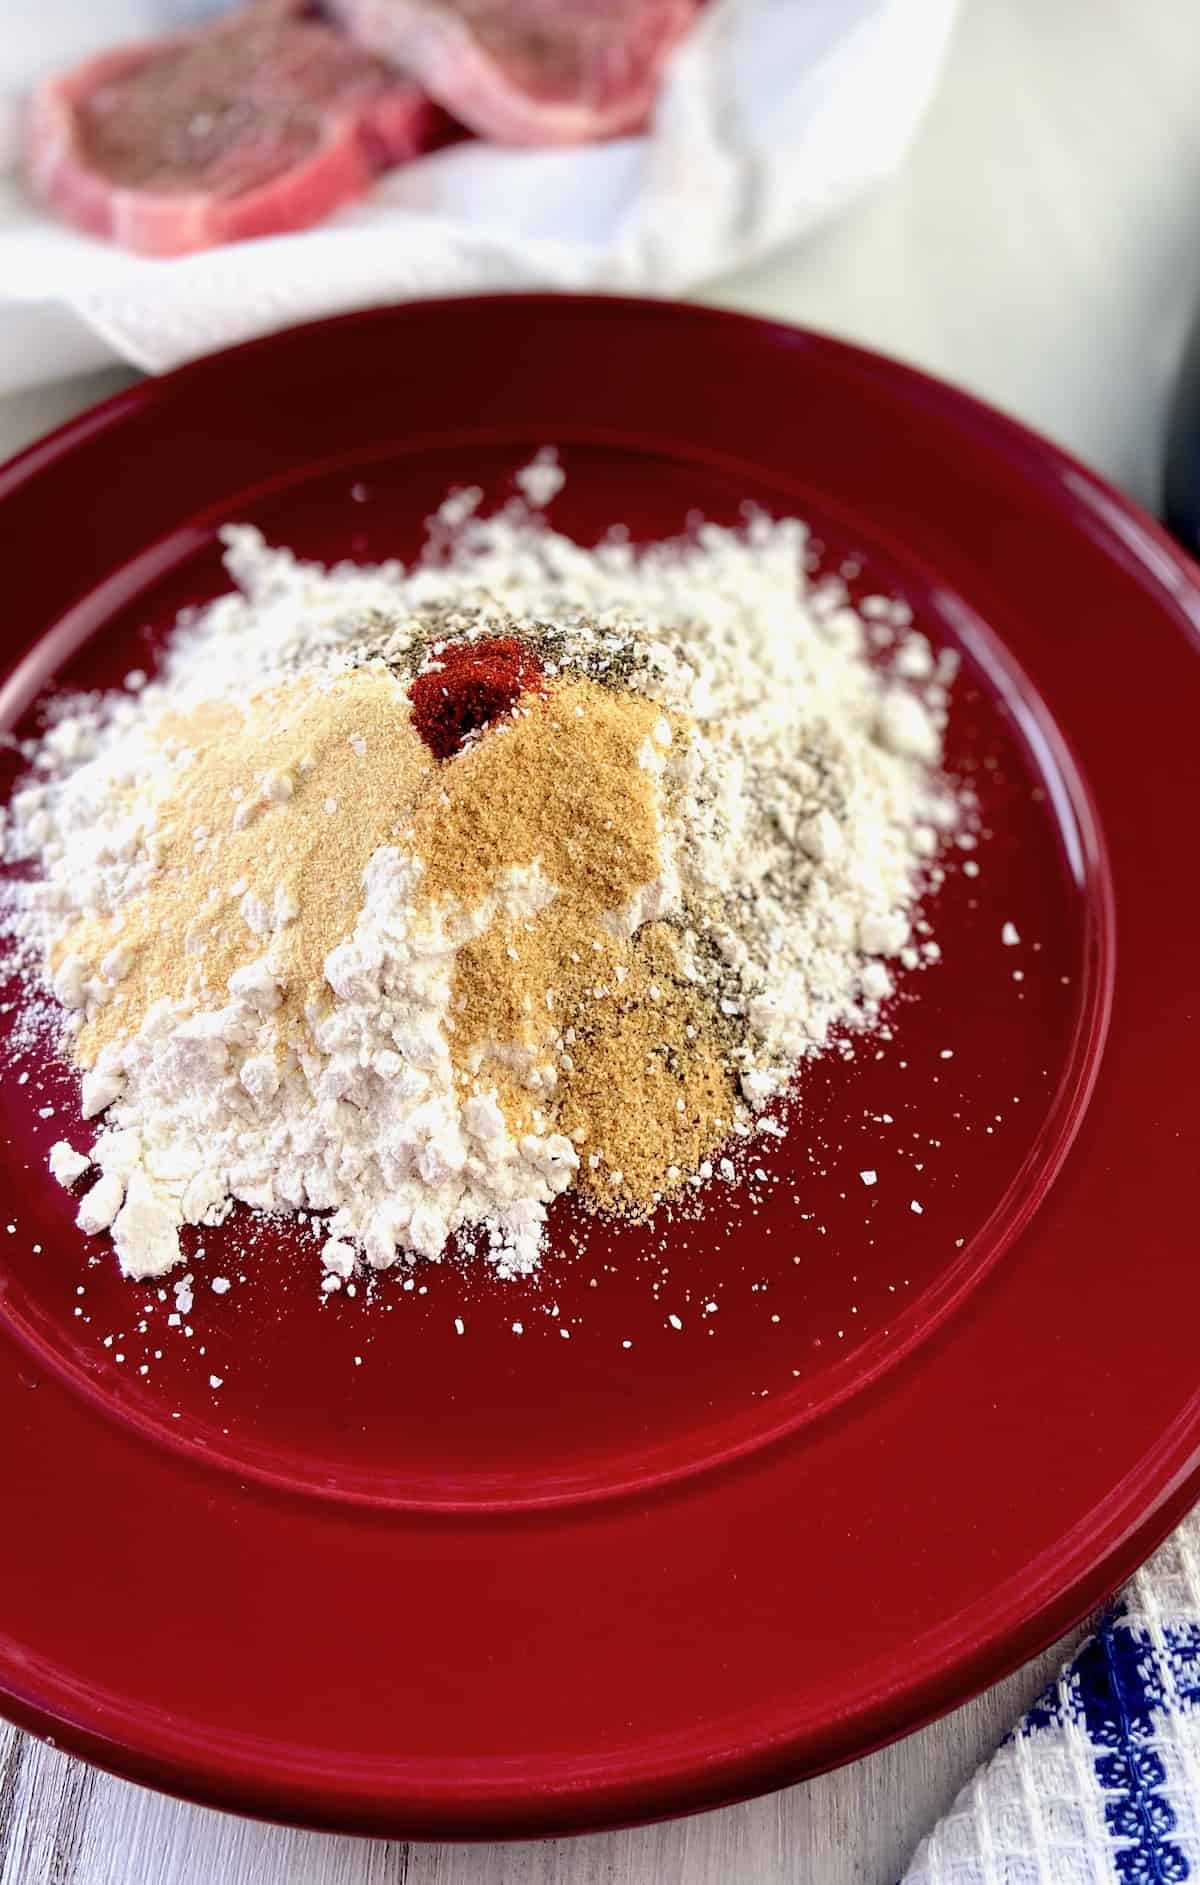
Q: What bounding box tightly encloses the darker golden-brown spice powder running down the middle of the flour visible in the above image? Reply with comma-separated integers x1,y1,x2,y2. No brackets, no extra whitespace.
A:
414,680,735,1214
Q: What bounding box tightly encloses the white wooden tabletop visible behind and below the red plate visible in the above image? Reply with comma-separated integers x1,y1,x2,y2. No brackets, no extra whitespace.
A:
0,0,1200,1885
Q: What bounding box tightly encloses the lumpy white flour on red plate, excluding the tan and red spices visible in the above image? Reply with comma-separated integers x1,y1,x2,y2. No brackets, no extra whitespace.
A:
8,478,959,1287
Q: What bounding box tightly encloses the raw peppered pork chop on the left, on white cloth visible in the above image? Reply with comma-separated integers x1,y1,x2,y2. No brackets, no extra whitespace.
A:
26,0,433,254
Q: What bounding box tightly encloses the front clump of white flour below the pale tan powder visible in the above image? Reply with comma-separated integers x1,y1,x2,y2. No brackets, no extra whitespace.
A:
66,848,576,1276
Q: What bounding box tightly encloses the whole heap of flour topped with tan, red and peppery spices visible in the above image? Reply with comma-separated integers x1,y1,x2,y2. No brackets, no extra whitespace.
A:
6,471,961,1289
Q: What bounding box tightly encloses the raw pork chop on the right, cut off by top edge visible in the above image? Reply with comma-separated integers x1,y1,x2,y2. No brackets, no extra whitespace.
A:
332,0,699,143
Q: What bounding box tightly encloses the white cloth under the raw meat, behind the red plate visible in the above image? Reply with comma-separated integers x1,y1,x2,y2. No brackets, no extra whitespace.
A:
0,0,955,388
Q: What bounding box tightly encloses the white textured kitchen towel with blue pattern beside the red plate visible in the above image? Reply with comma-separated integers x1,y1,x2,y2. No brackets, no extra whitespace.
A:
904,1512,1200,1885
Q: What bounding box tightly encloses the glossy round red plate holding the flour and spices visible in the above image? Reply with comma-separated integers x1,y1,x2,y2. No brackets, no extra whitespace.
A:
0,296,1200,1838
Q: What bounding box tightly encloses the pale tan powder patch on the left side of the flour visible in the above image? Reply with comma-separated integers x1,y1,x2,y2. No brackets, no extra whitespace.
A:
51,665,433,1067
